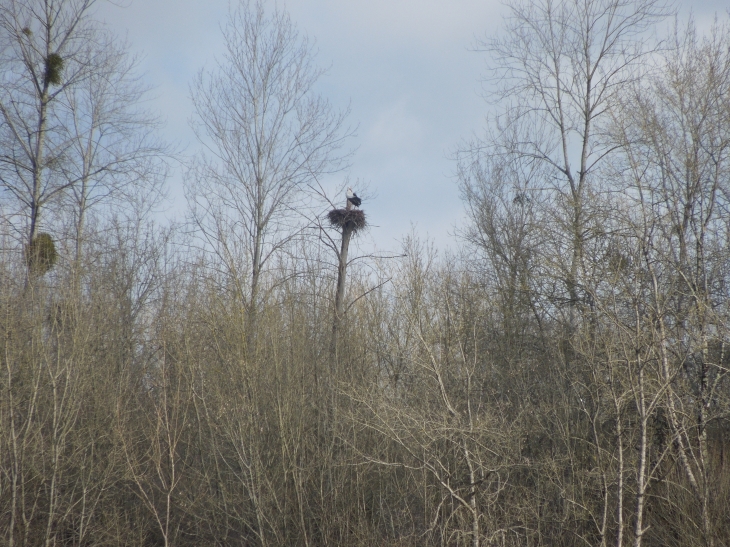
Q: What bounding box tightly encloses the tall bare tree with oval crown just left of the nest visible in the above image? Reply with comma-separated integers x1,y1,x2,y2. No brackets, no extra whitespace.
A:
188,0,348,342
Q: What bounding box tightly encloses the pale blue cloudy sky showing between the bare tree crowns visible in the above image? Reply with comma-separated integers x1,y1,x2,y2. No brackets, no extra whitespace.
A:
97,0,728,251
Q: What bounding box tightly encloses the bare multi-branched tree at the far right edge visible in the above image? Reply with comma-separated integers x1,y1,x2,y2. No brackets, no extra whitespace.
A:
616,16,730,546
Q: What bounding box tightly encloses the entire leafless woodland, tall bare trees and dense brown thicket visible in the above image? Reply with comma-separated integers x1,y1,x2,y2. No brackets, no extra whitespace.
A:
0,0,730,547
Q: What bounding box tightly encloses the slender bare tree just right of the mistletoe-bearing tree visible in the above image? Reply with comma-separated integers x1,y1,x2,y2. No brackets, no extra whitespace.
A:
60,32,169,263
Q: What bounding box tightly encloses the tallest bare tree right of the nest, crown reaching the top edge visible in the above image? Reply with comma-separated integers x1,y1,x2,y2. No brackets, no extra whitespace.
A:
460,0,667,324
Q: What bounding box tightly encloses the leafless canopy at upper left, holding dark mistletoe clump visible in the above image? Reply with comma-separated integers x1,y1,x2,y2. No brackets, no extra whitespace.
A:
0,0,167,262
